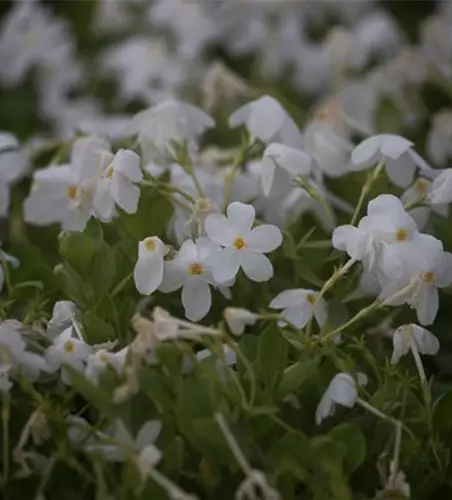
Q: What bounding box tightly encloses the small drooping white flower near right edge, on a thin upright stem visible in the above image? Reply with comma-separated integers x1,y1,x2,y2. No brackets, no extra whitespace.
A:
391,324,439,364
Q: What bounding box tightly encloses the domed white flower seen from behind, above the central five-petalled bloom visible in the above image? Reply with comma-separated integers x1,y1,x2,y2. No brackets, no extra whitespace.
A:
229,95,302,148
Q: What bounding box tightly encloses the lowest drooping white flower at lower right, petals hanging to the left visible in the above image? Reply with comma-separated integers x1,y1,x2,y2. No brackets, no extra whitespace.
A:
315,373,358,425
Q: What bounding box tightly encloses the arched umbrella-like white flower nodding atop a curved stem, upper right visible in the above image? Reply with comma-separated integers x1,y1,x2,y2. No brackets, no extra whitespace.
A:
349,134,430,187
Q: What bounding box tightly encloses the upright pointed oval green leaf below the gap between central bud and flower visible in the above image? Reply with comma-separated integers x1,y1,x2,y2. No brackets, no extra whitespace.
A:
257,326,288,391
